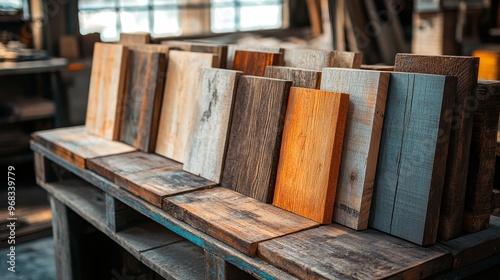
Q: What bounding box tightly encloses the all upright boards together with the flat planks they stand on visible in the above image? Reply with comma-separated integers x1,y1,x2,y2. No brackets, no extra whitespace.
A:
33,37,500,277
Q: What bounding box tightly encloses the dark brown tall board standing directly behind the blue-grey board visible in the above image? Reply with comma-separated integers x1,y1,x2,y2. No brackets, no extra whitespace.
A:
394,54,479,240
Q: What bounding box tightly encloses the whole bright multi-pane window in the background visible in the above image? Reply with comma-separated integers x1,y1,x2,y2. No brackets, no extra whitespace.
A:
78,0,283,41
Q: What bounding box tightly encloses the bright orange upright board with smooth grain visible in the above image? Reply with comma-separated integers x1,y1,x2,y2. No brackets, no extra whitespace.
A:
273,87,349,224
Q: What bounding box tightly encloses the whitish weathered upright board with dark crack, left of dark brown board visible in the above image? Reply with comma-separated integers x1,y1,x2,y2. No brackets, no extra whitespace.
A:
183,68,242,183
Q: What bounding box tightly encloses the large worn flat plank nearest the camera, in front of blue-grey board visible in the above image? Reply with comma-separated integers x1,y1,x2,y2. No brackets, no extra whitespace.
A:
258,224,451,279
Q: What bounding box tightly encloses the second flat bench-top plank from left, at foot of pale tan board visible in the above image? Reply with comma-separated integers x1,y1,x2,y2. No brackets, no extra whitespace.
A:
87,151,181,182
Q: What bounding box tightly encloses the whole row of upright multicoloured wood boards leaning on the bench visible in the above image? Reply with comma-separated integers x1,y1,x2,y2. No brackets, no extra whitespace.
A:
81,40,496,245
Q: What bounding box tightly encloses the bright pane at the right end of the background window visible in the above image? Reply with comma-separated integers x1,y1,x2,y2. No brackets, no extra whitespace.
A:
240,5,282,30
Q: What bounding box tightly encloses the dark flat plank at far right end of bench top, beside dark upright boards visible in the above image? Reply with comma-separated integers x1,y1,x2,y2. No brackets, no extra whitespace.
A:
438,216,500,270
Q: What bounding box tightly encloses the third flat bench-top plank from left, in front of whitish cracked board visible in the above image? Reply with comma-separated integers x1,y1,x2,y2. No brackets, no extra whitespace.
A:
116,165,216,207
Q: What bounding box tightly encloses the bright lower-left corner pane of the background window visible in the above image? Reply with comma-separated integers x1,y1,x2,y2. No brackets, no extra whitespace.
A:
78,11,118,41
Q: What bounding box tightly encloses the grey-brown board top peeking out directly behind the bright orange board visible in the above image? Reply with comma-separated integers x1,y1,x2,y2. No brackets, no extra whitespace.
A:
264,66,321,89
